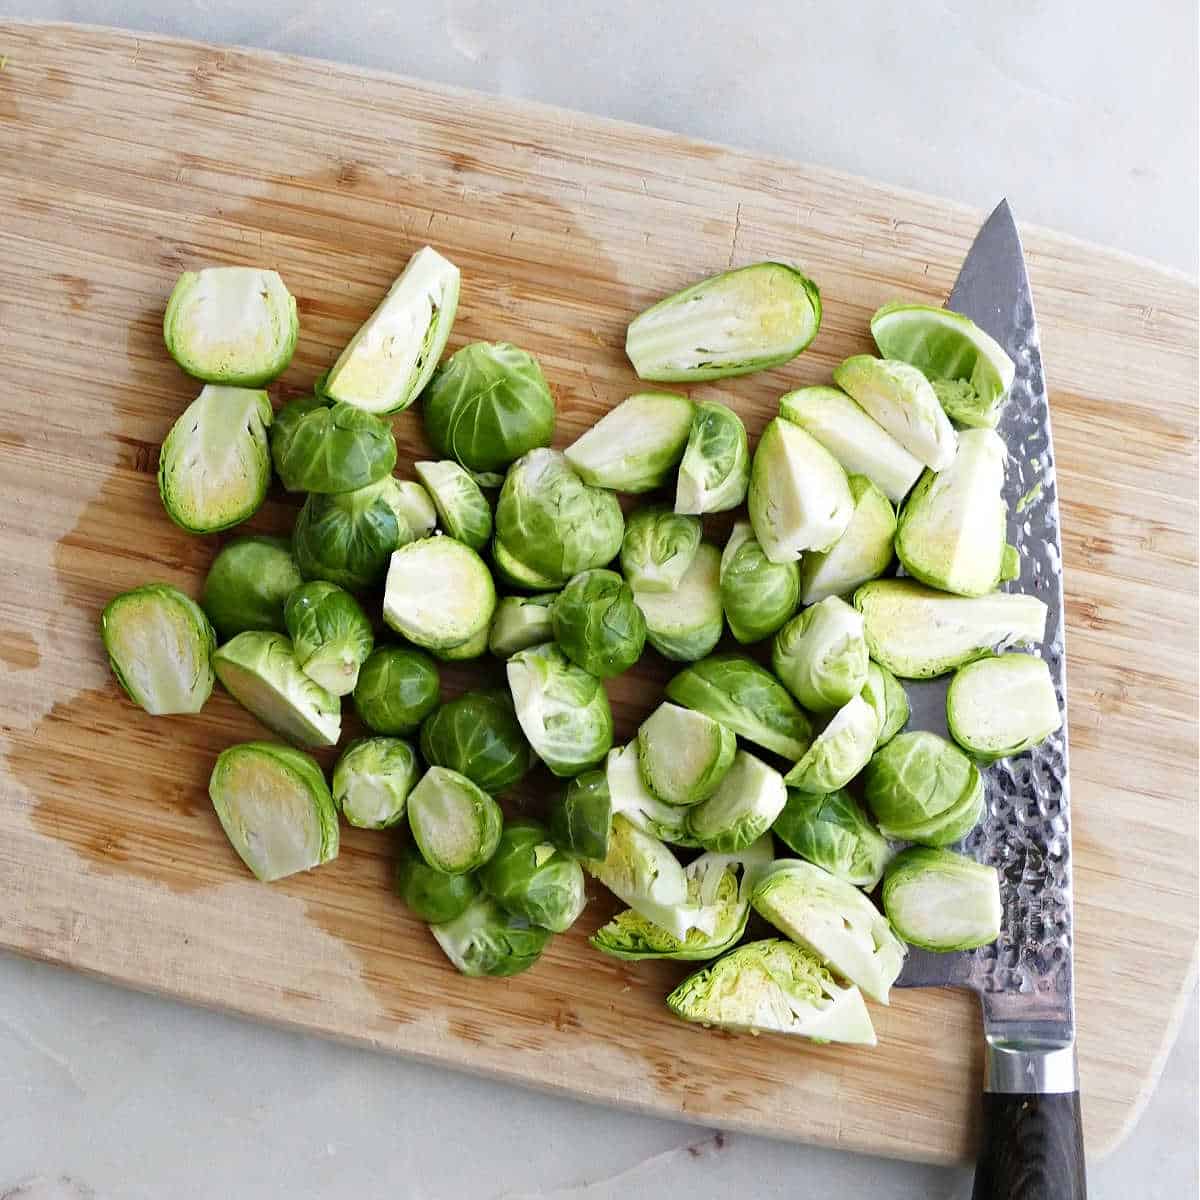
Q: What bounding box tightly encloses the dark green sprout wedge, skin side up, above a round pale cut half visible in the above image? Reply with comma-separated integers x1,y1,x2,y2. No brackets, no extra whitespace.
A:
667,654,812,758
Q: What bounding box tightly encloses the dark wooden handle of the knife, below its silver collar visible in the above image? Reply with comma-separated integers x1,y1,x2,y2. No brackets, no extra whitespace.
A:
971,1092,1087,1200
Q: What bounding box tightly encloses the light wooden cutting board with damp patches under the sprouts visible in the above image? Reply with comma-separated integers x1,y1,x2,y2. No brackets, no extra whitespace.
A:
0,25,1196,1162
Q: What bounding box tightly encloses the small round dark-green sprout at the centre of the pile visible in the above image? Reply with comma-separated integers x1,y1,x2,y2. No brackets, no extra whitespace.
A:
551,568,646,679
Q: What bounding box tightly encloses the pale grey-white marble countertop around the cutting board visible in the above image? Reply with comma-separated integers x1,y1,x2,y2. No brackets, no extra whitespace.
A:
0,0,1200,1200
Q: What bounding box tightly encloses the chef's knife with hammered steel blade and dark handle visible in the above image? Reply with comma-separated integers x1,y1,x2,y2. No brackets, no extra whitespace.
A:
898,200,1087,1200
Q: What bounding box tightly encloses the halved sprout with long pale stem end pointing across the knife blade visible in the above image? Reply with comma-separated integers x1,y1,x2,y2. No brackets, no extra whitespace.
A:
854,580,1048,679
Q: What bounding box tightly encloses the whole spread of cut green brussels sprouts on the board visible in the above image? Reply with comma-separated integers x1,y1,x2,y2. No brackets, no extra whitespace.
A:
102,247,1060,1044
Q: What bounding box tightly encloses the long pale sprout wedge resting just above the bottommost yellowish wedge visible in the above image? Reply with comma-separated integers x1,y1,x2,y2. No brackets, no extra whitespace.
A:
750,858,906,1004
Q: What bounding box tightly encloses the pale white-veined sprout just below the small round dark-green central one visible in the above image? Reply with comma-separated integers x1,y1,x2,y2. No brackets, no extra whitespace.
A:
506,643,612,776
